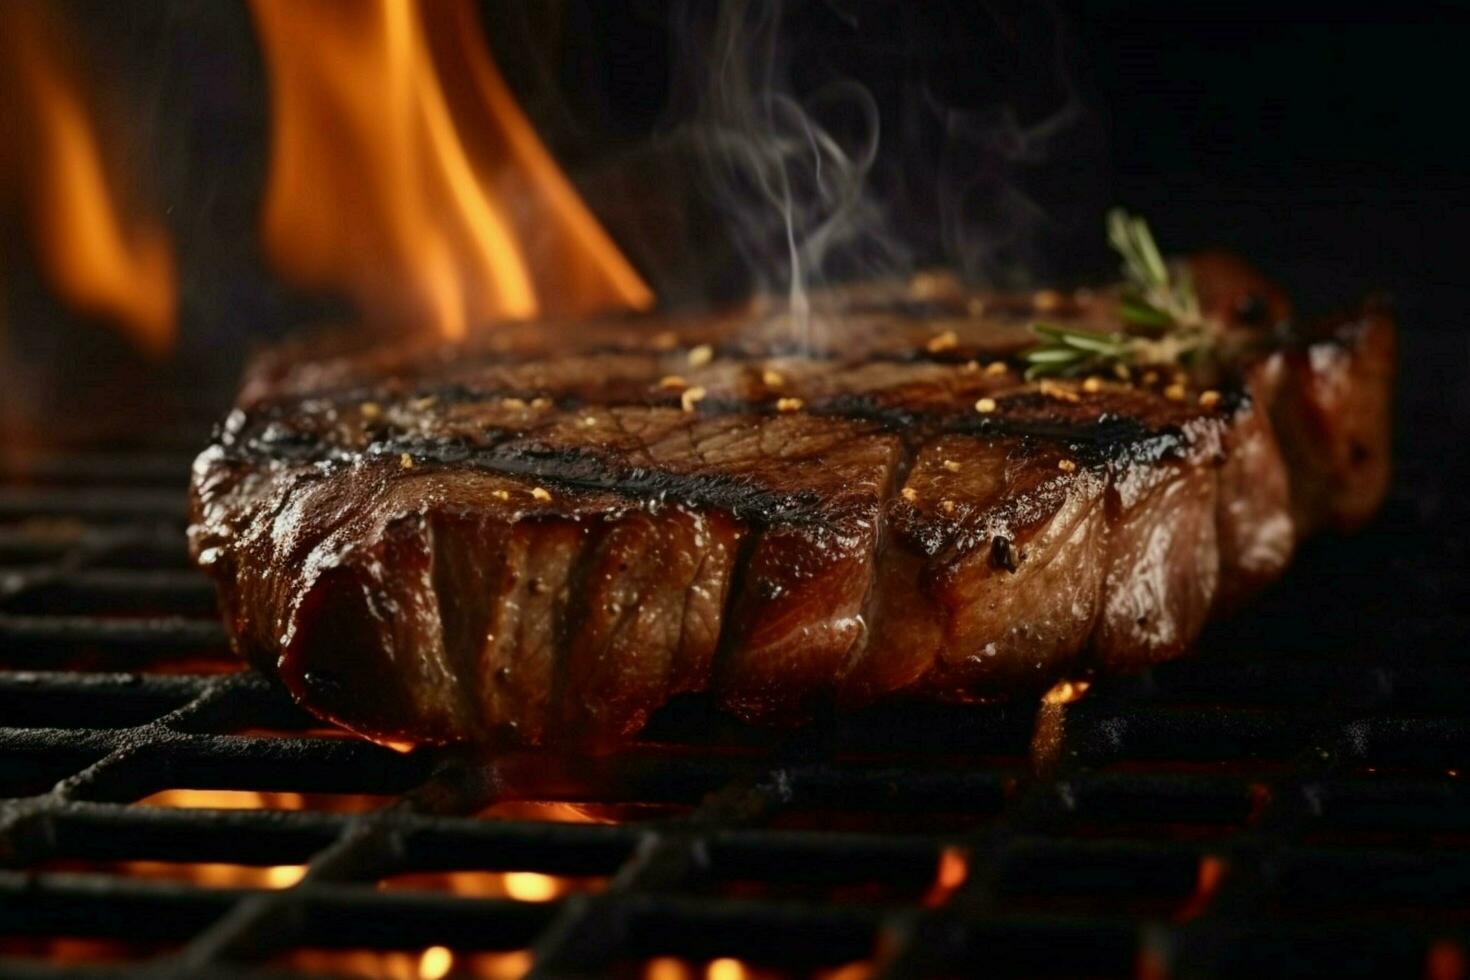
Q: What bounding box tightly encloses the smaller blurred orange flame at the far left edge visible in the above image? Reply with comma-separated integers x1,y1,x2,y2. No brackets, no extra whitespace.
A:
0,3,178,356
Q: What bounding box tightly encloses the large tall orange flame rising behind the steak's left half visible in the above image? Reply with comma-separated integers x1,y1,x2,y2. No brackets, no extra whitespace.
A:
250,0,653,338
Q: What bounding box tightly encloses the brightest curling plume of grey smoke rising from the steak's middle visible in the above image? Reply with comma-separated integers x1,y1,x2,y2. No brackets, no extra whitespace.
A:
676,0,911,344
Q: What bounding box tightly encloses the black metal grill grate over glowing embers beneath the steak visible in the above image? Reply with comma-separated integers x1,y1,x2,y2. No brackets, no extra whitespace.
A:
0,417,1470,977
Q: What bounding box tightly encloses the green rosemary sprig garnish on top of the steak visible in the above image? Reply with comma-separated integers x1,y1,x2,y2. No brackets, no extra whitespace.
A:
1022,209,1217,381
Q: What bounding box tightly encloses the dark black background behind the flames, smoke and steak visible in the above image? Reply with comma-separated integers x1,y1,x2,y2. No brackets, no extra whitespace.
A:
0,0,1470,446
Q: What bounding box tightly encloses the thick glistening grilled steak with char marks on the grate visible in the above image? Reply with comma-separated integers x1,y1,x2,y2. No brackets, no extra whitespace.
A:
190,257,1394,743
